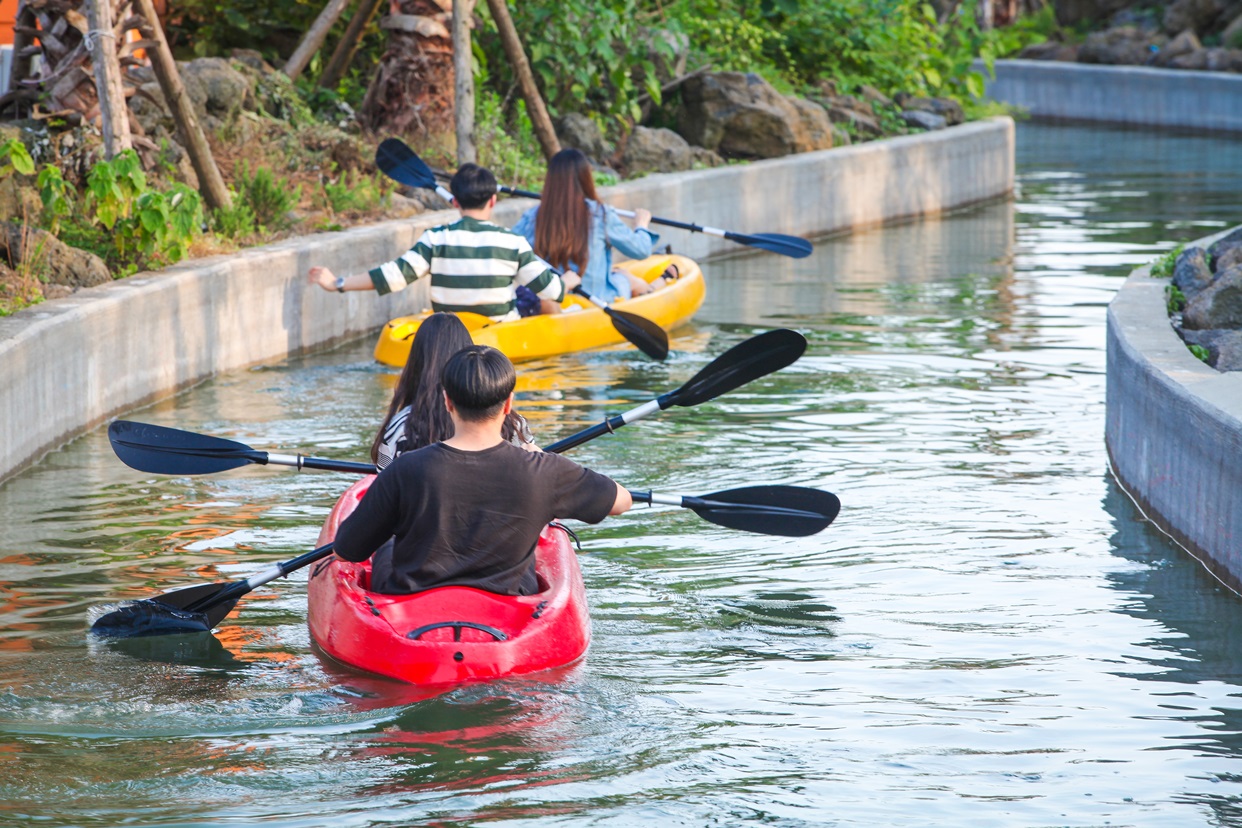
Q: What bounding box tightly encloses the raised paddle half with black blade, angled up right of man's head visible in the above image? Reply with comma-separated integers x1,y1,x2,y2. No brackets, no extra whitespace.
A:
544,328,806,454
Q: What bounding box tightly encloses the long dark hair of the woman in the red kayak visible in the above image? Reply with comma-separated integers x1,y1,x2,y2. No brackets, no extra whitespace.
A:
371,313,522,463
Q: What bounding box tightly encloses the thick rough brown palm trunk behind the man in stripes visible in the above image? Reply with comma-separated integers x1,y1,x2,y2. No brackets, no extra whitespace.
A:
359,0,453,138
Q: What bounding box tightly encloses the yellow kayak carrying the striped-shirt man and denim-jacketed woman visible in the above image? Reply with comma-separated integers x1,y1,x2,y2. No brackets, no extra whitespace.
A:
375,254,705,367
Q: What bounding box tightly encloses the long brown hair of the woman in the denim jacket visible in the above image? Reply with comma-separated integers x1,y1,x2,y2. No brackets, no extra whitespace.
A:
535,149,599,273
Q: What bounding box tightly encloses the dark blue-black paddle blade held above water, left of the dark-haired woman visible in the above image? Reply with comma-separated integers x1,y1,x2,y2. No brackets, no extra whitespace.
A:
108,420,266,474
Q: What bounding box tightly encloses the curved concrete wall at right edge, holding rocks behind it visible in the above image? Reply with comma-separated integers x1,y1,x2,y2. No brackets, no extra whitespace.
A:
1104,227,1242,588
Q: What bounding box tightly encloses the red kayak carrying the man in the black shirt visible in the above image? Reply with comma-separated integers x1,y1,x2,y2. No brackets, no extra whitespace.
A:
308,477,591,684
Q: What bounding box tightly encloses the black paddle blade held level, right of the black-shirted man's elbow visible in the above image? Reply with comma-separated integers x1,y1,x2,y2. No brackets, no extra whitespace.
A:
684,485,841,538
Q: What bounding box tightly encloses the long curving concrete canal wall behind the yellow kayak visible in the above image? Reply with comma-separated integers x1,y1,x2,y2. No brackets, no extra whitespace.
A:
0,118,1013,479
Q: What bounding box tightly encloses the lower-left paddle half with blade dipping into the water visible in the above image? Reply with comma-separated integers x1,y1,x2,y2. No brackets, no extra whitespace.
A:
91,544,332,638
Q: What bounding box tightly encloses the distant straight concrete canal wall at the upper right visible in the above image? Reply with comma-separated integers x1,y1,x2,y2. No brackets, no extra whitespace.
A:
987,61,1242,132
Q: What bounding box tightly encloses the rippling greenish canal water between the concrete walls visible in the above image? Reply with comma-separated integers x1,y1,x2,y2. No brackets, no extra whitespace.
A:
0,124,1242,828
